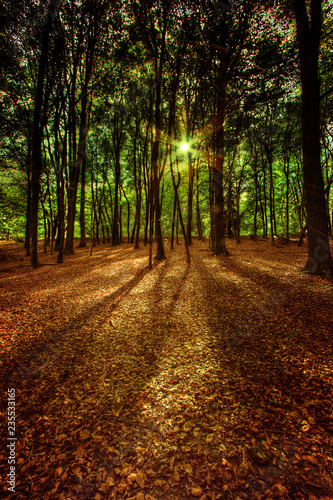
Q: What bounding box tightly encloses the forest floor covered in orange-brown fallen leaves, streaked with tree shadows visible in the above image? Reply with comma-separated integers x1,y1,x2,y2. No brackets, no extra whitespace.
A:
0,238,333,500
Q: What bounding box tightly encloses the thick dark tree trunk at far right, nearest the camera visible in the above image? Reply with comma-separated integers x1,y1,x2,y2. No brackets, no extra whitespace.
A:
293,0,333,274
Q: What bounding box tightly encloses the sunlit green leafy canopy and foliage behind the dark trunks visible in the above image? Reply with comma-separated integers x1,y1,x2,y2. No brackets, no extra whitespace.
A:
0,0,333,250
